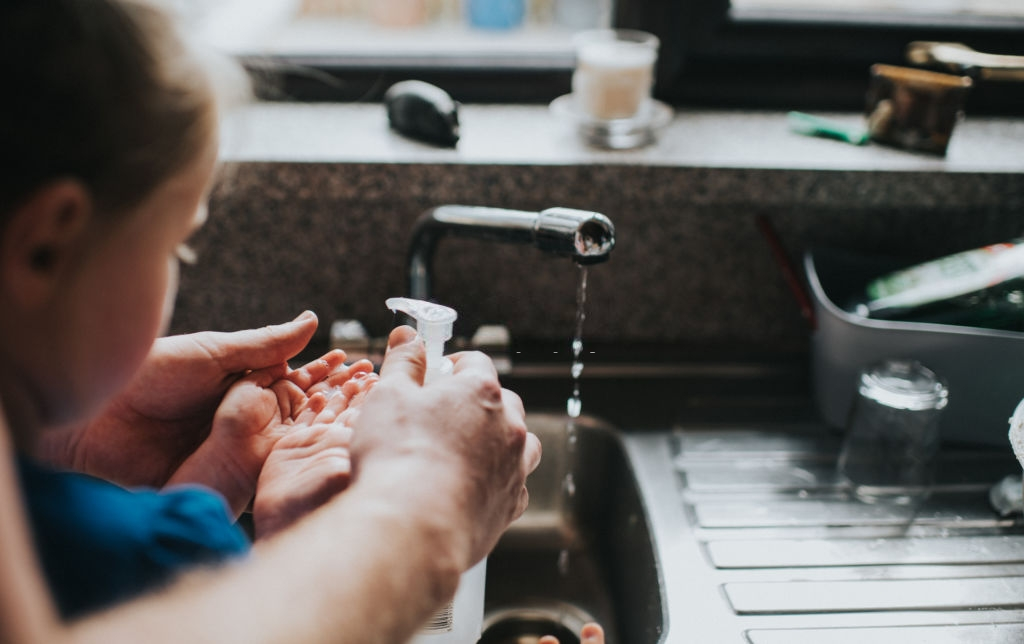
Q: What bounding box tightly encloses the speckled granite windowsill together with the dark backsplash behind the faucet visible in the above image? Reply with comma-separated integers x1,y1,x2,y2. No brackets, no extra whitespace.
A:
173,104,1024,353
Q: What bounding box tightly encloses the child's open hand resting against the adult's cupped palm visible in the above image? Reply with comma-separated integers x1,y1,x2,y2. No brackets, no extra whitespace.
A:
168,351,376,516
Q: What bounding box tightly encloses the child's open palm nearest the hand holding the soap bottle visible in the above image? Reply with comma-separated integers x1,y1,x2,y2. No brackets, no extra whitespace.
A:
253,374,377,539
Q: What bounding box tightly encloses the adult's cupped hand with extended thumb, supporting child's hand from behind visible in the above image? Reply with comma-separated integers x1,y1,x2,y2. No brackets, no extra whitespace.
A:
38,311,316,487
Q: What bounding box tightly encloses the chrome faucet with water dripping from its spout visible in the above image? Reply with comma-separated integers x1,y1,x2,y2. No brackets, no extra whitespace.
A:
408,205,615,300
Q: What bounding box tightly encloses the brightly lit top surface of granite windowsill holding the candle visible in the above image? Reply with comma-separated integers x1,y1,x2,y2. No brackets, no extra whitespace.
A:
222,102,1024,173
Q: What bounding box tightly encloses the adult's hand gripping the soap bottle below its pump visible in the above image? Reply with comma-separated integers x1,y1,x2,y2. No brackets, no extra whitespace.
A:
351,327,541,569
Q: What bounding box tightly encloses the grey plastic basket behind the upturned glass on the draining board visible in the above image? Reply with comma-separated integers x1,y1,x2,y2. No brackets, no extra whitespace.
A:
804,249,1024,448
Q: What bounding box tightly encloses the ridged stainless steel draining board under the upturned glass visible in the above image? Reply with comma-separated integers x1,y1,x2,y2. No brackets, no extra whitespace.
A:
627,426,1024,644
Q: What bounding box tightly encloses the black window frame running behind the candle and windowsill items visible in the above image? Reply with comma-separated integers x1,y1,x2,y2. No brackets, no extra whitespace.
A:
242,0,1024,116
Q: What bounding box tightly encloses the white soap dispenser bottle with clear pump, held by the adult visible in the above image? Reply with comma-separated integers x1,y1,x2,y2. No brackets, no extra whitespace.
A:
384,297,487,644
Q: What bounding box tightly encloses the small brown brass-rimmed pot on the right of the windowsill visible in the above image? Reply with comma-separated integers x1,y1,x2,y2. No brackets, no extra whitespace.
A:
866,65,972,155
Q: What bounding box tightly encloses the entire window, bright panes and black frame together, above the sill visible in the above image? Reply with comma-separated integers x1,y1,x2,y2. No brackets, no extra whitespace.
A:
164,0,1024,115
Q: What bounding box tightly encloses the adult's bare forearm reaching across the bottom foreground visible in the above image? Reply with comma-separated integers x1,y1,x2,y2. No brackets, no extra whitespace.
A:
68,473,466,644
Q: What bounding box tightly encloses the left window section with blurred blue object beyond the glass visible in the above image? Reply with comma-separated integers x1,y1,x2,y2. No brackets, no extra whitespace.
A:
164,0,611,101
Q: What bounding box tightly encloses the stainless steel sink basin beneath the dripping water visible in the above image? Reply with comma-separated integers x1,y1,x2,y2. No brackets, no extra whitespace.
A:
480,414,666,644
